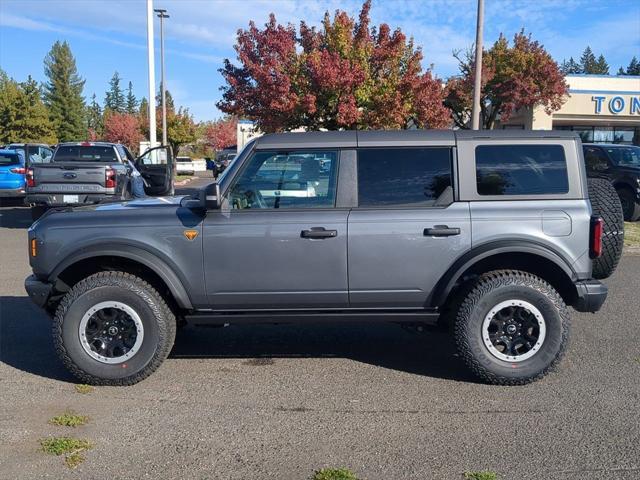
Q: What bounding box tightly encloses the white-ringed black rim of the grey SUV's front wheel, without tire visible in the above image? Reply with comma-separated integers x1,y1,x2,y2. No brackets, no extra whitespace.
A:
78,301,144,364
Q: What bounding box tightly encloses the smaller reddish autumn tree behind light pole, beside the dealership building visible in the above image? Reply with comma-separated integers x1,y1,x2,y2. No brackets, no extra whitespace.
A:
445,31,568,129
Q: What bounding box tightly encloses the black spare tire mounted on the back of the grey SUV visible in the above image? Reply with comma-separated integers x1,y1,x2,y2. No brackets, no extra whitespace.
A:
587,178,624,278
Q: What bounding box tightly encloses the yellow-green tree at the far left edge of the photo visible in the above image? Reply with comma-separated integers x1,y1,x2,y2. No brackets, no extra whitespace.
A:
0,70,56,143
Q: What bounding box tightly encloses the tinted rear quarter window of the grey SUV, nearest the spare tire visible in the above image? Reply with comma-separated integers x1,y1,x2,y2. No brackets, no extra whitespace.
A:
475,145,569,195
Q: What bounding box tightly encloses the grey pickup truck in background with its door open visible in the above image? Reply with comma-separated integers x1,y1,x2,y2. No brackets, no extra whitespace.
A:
25,142,173,219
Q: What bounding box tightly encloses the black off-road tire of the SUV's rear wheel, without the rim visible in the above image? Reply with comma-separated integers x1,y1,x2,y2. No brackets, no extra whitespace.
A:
454,270,570,385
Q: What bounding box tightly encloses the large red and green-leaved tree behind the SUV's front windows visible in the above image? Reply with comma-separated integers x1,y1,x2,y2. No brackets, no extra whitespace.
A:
217,0,450,132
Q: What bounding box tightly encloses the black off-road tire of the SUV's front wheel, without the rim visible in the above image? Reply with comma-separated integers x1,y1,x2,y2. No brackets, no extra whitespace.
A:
53,272,176,386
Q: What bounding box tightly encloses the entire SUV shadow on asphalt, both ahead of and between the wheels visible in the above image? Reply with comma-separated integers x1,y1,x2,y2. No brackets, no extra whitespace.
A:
0,296,475,383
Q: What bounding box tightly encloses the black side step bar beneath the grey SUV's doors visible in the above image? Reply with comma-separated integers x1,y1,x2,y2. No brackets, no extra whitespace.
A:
184,309,440,325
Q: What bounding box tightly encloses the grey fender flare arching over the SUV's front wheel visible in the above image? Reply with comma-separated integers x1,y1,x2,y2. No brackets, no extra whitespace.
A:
49,242,193,310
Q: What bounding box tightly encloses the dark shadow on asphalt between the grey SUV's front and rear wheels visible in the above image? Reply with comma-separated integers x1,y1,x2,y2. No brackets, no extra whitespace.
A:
170,321,475,382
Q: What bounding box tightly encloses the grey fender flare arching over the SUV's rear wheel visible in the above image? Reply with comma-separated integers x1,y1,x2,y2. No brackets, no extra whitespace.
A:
429,240,577,307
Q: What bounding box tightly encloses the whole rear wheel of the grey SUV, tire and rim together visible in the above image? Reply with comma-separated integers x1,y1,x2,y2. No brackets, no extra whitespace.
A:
454,270,569,385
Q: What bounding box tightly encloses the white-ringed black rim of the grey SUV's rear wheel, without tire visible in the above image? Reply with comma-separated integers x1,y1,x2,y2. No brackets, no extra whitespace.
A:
482,299,547,363
